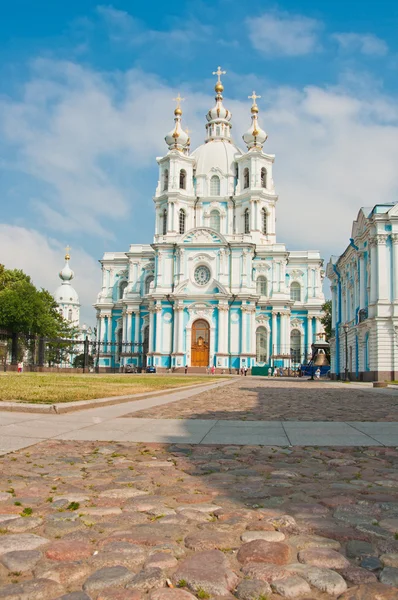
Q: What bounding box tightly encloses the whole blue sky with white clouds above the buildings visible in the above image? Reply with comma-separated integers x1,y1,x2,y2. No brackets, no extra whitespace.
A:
0,0,398,320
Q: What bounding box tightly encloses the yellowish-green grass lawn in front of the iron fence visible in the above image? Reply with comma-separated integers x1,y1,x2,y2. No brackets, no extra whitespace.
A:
0,373,222,404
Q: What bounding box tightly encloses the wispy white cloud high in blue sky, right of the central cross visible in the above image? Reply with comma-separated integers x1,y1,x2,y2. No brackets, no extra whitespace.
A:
247,11,322,58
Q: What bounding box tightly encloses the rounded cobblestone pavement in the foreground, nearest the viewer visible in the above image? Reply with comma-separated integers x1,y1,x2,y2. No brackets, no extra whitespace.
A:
0,438,398,600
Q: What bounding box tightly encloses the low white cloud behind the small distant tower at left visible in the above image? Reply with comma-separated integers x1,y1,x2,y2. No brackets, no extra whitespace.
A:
0,224,101,325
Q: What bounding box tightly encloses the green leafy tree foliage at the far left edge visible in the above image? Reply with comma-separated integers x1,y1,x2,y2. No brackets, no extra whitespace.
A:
0,264,73,338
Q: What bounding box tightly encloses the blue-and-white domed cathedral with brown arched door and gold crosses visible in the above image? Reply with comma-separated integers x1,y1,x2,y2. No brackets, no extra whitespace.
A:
95,67,324,372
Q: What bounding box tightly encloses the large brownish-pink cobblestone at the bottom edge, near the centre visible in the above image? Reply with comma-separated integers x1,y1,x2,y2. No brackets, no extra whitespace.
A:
172,550,238,596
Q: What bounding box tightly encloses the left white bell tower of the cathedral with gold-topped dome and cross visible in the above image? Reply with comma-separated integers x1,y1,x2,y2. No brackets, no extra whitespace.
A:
154,94,195,242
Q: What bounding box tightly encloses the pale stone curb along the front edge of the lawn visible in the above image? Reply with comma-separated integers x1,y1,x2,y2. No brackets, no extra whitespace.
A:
0,379,235,415
